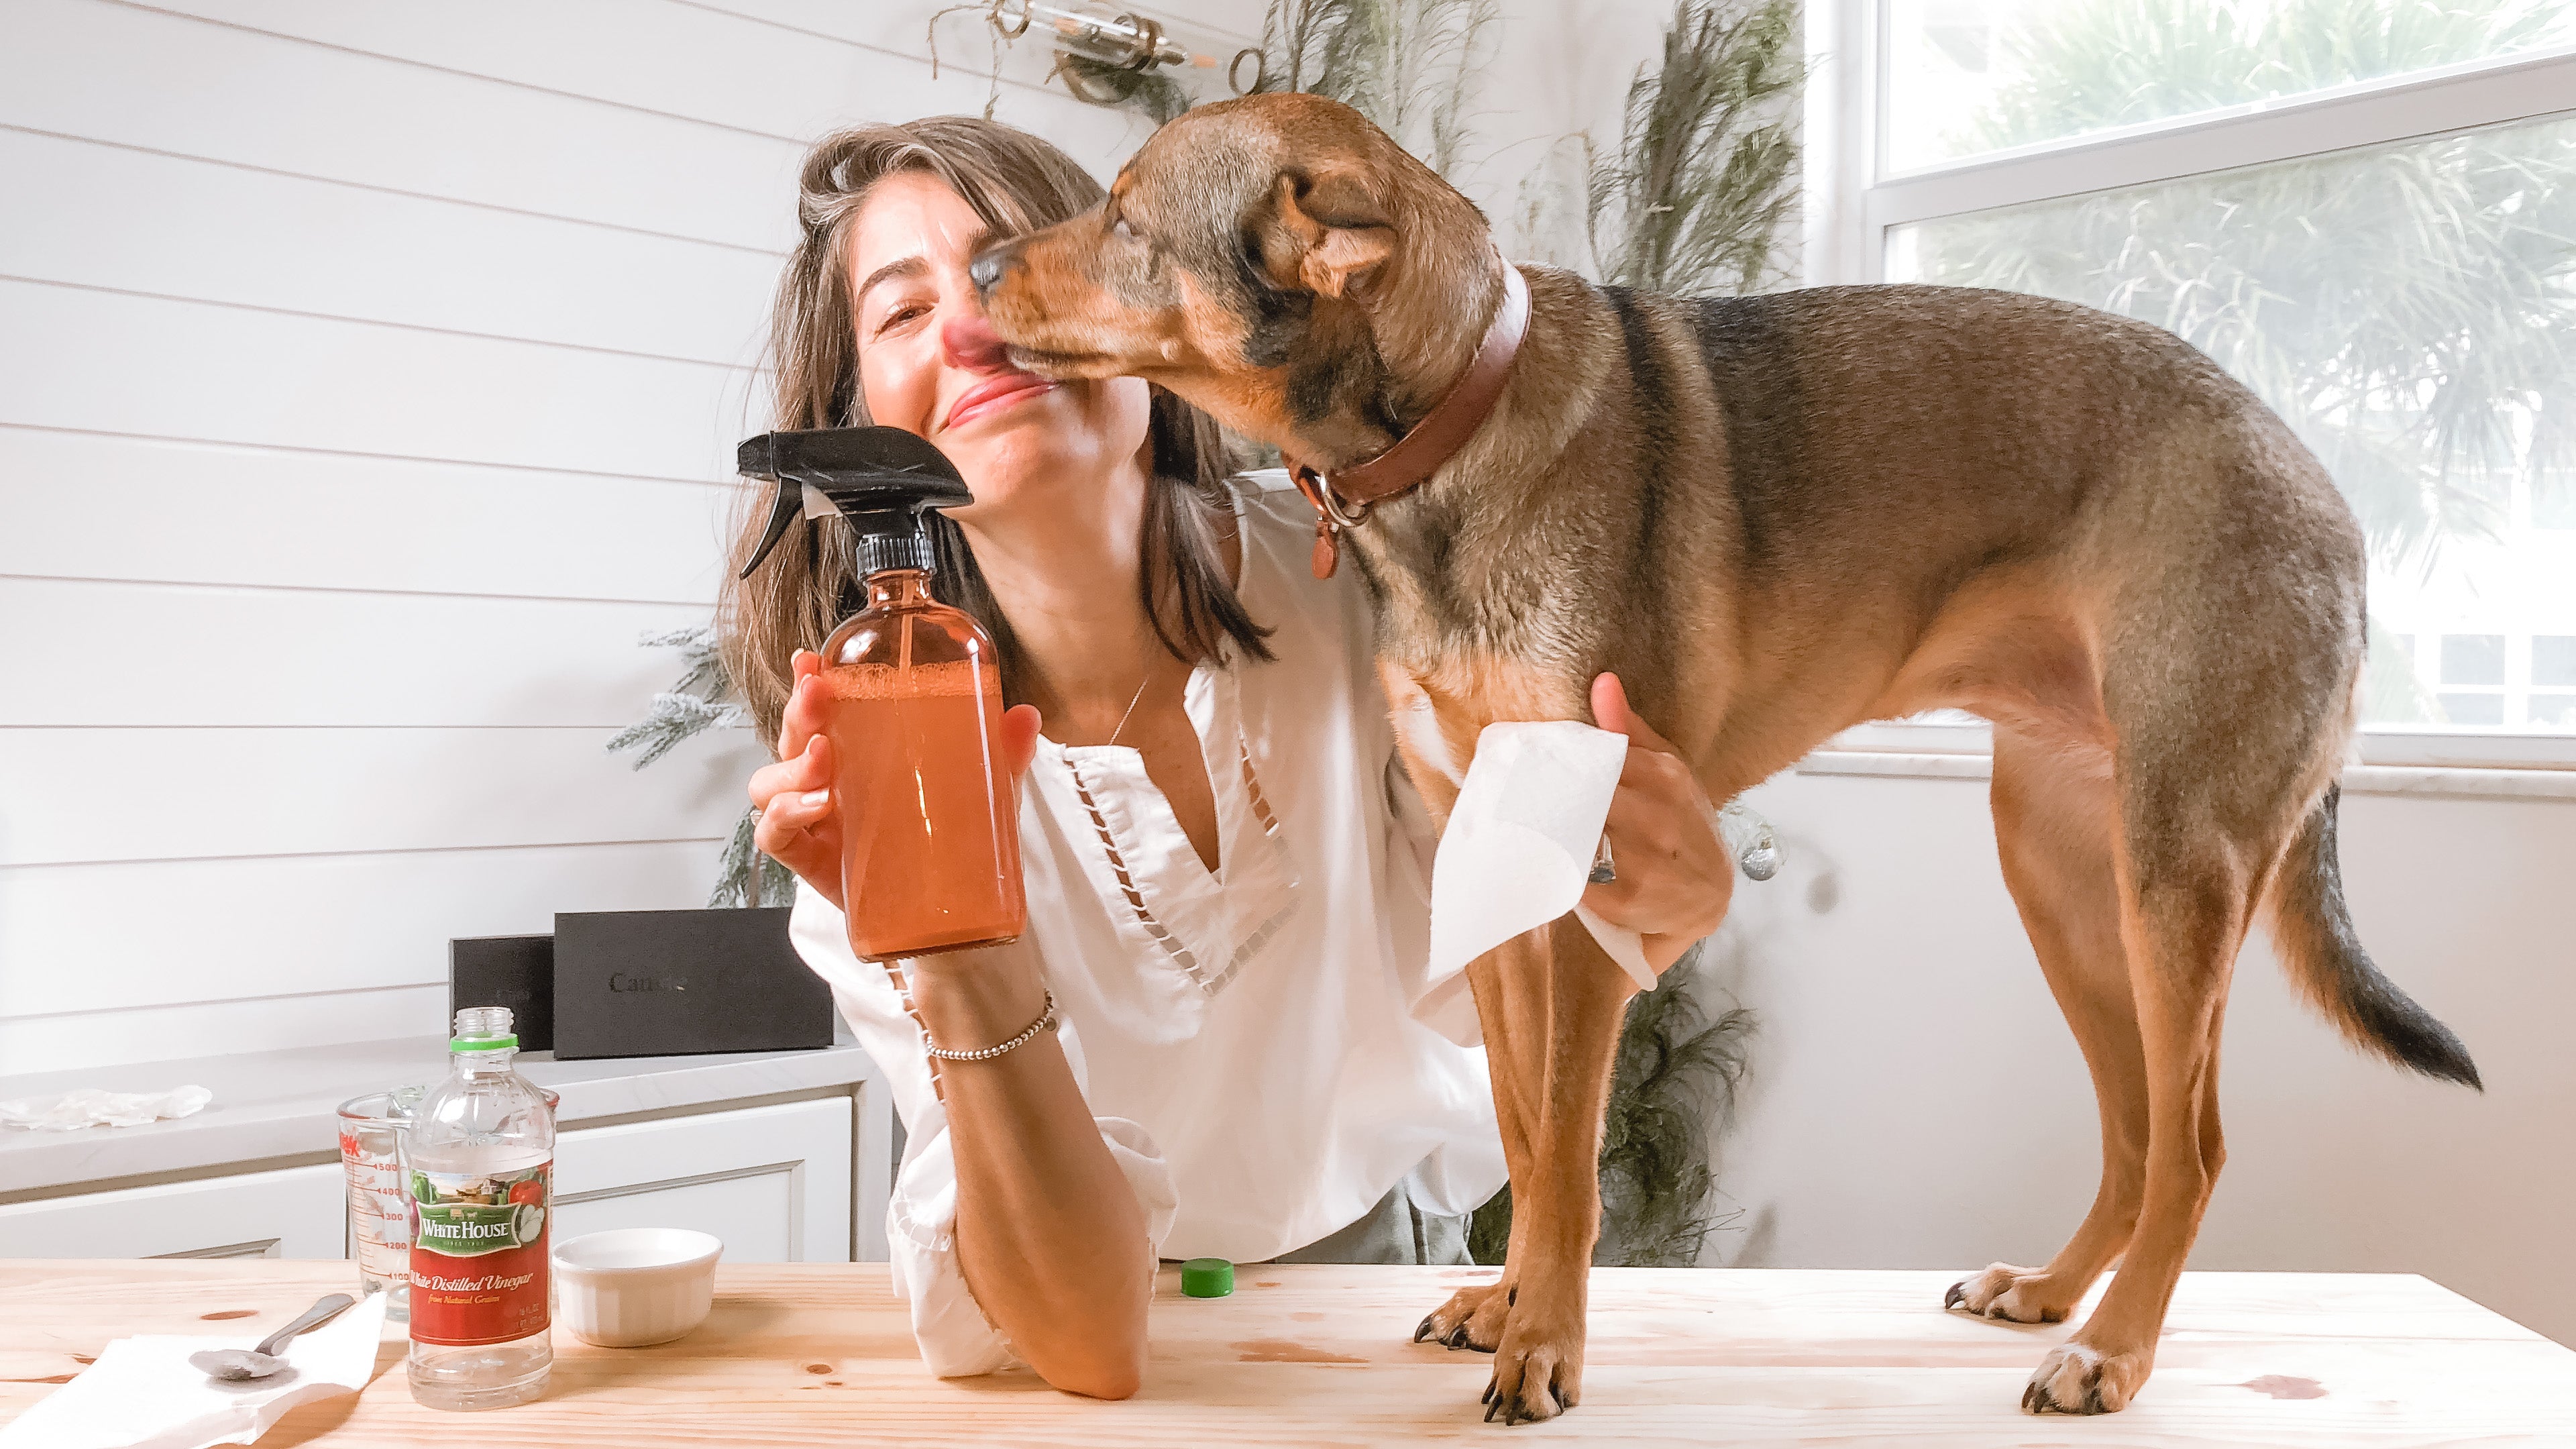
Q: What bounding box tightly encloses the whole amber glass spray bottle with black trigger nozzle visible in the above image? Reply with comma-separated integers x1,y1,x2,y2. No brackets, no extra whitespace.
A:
737,428,1028,962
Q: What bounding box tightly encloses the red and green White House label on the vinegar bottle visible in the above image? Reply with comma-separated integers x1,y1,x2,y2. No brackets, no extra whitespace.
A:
412,1161,554,1348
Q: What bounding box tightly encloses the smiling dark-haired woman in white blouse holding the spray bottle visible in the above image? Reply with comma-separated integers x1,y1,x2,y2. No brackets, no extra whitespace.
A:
727,116,1731,1397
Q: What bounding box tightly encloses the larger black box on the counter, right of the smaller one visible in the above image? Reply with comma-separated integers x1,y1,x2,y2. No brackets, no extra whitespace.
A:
554,905,832,1062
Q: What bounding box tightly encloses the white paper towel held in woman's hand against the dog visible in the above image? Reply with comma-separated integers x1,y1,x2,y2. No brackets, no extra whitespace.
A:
1430,719,1654,990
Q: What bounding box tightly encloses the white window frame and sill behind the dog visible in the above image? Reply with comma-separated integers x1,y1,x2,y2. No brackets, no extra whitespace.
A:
1801,0,2576,768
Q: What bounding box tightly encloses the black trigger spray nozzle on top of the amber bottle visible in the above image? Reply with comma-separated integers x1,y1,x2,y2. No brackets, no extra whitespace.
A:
734,428,974,578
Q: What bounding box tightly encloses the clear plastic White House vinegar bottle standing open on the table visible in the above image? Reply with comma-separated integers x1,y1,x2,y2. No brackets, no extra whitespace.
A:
402,1006,554,1410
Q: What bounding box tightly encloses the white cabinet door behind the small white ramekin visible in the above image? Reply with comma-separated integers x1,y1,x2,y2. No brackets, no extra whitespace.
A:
554,1095,850,1263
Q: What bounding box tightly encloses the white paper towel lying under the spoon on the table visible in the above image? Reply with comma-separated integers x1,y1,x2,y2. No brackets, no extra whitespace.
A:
0,1279,386,1449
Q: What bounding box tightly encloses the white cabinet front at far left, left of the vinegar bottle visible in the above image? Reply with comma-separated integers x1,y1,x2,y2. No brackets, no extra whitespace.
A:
0,1163,347,1258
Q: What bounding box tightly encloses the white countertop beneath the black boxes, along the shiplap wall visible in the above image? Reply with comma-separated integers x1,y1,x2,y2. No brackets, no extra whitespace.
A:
0,1036,878,1196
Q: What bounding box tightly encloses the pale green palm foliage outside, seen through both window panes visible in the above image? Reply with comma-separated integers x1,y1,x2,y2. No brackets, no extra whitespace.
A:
1917,0,2576,588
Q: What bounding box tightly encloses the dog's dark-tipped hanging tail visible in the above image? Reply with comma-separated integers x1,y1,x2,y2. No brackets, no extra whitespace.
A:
2272,786,2486,1091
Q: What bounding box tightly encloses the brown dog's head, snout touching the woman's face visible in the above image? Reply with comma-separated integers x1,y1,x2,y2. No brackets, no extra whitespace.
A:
969,95,1494,464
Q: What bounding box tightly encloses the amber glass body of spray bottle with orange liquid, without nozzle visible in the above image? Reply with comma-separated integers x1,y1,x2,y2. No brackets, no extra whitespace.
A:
822,570,1028,959
